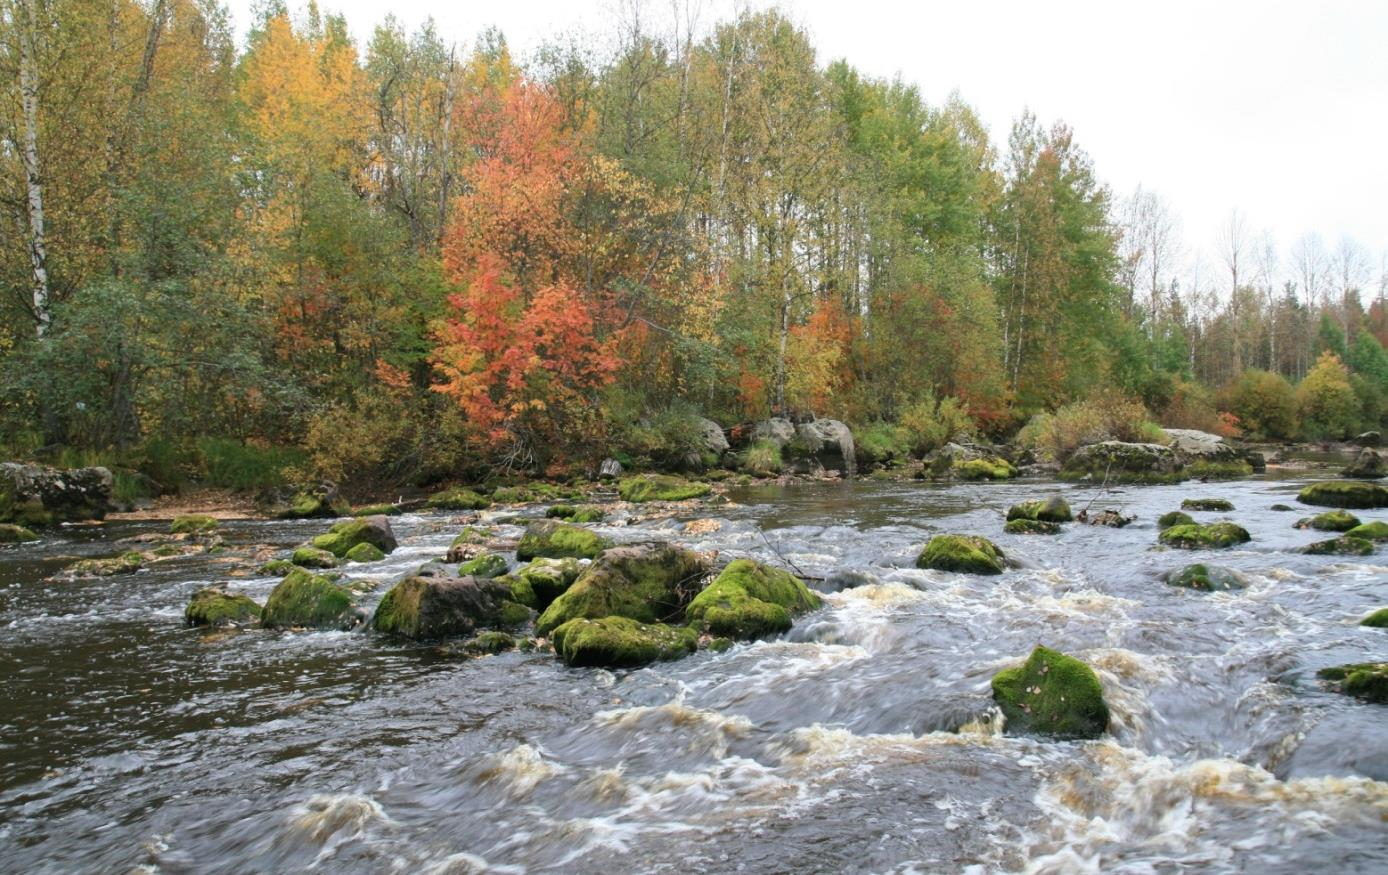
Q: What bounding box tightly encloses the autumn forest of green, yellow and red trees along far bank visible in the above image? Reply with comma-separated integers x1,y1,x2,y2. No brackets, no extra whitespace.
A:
0,0,1388,490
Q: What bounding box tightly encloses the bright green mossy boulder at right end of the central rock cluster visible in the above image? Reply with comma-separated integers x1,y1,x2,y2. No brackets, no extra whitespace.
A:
684,560,822,639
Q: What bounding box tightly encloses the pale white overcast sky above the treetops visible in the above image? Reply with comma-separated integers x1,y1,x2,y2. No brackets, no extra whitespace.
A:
230,0,1388,290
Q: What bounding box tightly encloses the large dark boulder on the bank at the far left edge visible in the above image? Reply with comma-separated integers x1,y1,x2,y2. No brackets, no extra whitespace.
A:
0,463,114,526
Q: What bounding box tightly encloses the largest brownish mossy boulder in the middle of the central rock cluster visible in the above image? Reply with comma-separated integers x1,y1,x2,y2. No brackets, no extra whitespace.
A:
536,543,708,635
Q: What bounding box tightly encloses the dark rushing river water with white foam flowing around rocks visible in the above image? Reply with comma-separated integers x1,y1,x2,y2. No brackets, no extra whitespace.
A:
0,479,1388,874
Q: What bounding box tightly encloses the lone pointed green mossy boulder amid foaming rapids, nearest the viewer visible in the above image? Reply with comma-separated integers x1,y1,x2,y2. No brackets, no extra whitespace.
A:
992,647,1109,739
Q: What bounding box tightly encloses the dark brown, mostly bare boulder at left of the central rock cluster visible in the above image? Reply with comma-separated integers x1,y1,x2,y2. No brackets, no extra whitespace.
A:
371,576,530,640
